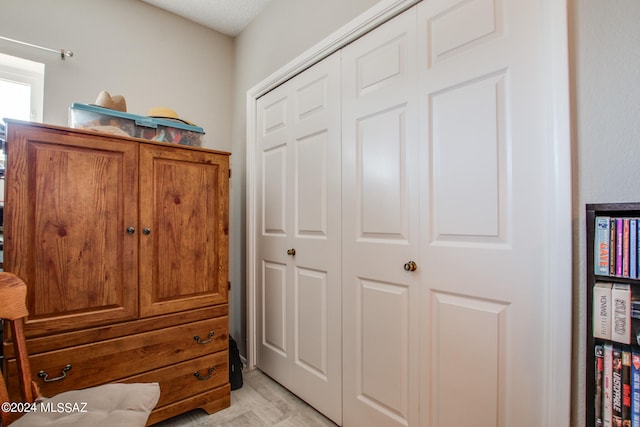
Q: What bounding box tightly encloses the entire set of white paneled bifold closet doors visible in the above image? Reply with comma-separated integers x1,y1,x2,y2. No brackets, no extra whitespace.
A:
256,0,571,427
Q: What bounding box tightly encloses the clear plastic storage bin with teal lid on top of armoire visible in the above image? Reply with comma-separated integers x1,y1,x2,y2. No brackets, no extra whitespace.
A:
69,102,204,147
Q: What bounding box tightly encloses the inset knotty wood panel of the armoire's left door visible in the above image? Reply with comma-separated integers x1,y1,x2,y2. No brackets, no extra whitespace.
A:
29,143,123,310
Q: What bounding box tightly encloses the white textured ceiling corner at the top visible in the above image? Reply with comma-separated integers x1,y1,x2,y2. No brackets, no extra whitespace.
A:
142,0,271,37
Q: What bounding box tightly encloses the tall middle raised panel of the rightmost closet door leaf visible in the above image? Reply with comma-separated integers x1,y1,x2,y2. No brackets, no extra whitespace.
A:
429,73,509,243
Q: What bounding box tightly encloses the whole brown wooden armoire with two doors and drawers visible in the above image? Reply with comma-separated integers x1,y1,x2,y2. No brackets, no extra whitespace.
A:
3,121,230,424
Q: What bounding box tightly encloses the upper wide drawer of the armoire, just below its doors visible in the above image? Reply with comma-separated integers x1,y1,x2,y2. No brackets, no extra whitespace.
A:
7,316,229,396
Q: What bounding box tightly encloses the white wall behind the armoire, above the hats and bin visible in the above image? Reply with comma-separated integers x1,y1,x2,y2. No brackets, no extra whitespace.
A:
0,0,234,151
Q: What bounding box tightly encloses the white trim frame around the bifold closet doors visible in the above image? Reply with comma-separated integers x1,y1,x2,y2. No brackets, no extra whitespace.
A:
246,0,573,426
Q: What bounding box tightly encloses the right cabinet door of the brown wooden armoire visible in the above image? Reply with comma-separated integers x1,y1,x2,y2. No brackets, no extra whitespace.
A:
139,144,229,317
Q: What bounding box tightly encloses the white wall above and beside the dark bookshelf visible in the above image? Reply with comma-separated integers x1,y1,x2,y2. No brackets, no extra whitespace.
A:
569,0,640,427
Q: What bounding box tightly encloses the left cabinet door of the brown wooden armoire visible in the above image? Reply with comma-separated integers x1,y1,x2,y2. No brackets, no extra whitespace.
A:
4,123,138,336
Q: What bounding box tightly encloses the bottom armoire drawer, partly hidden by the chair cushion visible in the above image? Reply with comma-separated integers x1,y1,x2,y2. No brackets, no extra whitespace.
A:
122,351,229,408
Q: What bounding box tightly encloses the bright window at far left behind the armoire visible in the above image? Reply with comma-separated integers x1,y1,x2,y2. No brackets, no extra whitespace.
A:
0,53,44,122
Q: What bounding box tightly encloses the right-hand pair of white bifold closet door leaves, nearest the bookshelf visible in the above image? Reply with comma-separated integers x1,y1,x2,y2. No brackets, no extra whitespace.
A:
342,0,571,427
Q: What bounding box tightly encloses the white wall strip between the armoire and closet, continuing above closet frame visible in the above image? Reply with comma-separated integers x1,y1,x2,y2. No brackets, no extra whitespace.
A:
230,0,379,354
